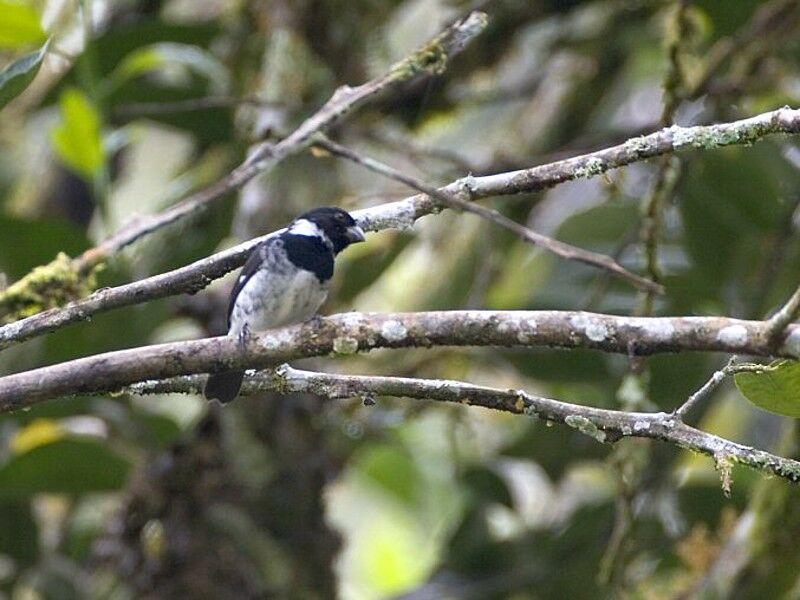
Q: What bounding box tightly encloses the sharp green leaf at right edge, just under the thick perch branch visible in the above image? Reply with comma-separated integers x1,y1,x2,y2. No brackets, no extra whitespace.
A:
734,360,800,418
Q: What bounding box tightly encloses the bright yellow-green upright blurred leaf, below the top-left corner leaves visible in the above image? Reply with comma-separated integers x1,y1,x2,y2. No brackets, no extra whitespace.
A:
52,88,106,180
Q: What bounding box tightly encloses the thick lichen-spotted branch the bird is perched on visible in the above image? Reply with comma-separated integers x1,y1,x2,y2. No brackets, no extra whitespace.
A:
0,310,800,412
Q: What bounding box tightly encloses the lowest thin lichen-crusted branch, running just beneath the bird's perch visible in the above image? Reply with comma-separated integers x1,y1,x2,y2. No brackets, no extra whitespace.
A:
125,367,800,483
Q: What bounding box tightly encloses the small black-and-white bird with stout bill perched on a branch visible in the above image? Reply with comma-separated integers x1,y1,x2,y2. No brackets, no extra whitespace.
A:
203,206,365,404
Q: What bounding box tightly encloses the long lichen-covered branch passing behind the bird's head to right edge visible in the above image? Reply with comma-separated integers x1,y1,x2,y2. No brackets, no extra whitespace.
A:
0,108,800,349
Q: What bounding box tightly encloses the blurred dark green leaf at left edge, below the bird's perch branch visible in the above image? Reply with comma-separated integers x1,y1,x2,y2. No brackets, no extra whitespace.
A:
0,437,130,497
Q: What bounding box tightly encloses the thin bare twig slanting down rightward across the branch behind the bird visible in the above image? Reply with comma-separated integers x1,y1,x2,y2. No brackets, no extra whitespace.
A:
315,136,664,294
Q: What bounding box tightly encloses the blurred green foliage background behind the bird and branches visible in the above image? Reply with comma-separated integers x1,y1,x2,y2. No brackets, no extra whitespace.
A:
0,0,800,600
